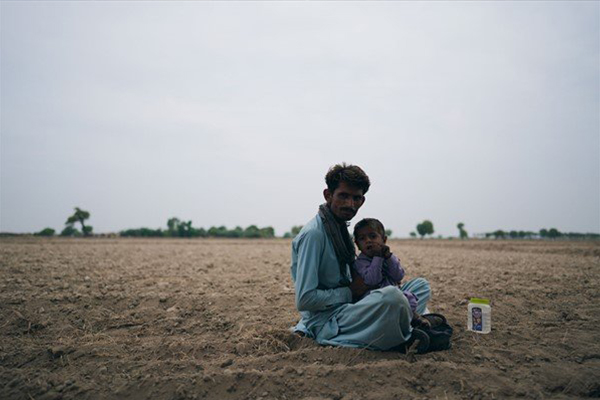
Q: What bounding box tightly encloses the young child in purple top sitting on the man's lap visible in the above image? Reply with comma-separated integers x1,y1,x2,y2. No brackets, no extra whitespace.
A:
354,218,423,323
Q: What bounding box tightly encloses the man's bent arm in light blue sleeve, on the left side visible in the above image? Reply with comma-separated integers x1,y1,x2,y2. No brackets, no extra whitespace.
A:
295,231,352,312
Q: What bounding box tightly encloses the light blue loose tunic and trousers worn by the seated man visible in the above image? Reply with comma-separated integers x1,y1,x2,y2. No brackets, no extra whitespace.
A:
291,215,430,350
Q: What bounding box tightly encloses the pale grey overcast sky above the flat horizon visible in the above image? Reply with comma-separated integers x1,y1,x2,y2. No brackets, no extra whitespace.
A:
0,1,600,237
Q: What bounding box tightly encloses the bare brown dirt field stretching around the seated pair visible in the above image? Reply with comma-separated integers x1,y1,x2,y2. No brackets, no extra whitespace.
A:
0,237,600,399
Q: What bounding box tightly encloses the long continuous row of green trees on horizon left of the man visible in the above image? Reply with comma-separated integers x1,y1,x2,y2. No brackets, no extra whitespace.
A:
119,217,275,238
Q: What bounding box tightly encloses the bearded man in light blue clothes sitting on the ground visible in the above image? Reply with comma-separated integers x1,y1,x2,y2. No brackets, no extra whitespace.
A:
291,163,430,350
